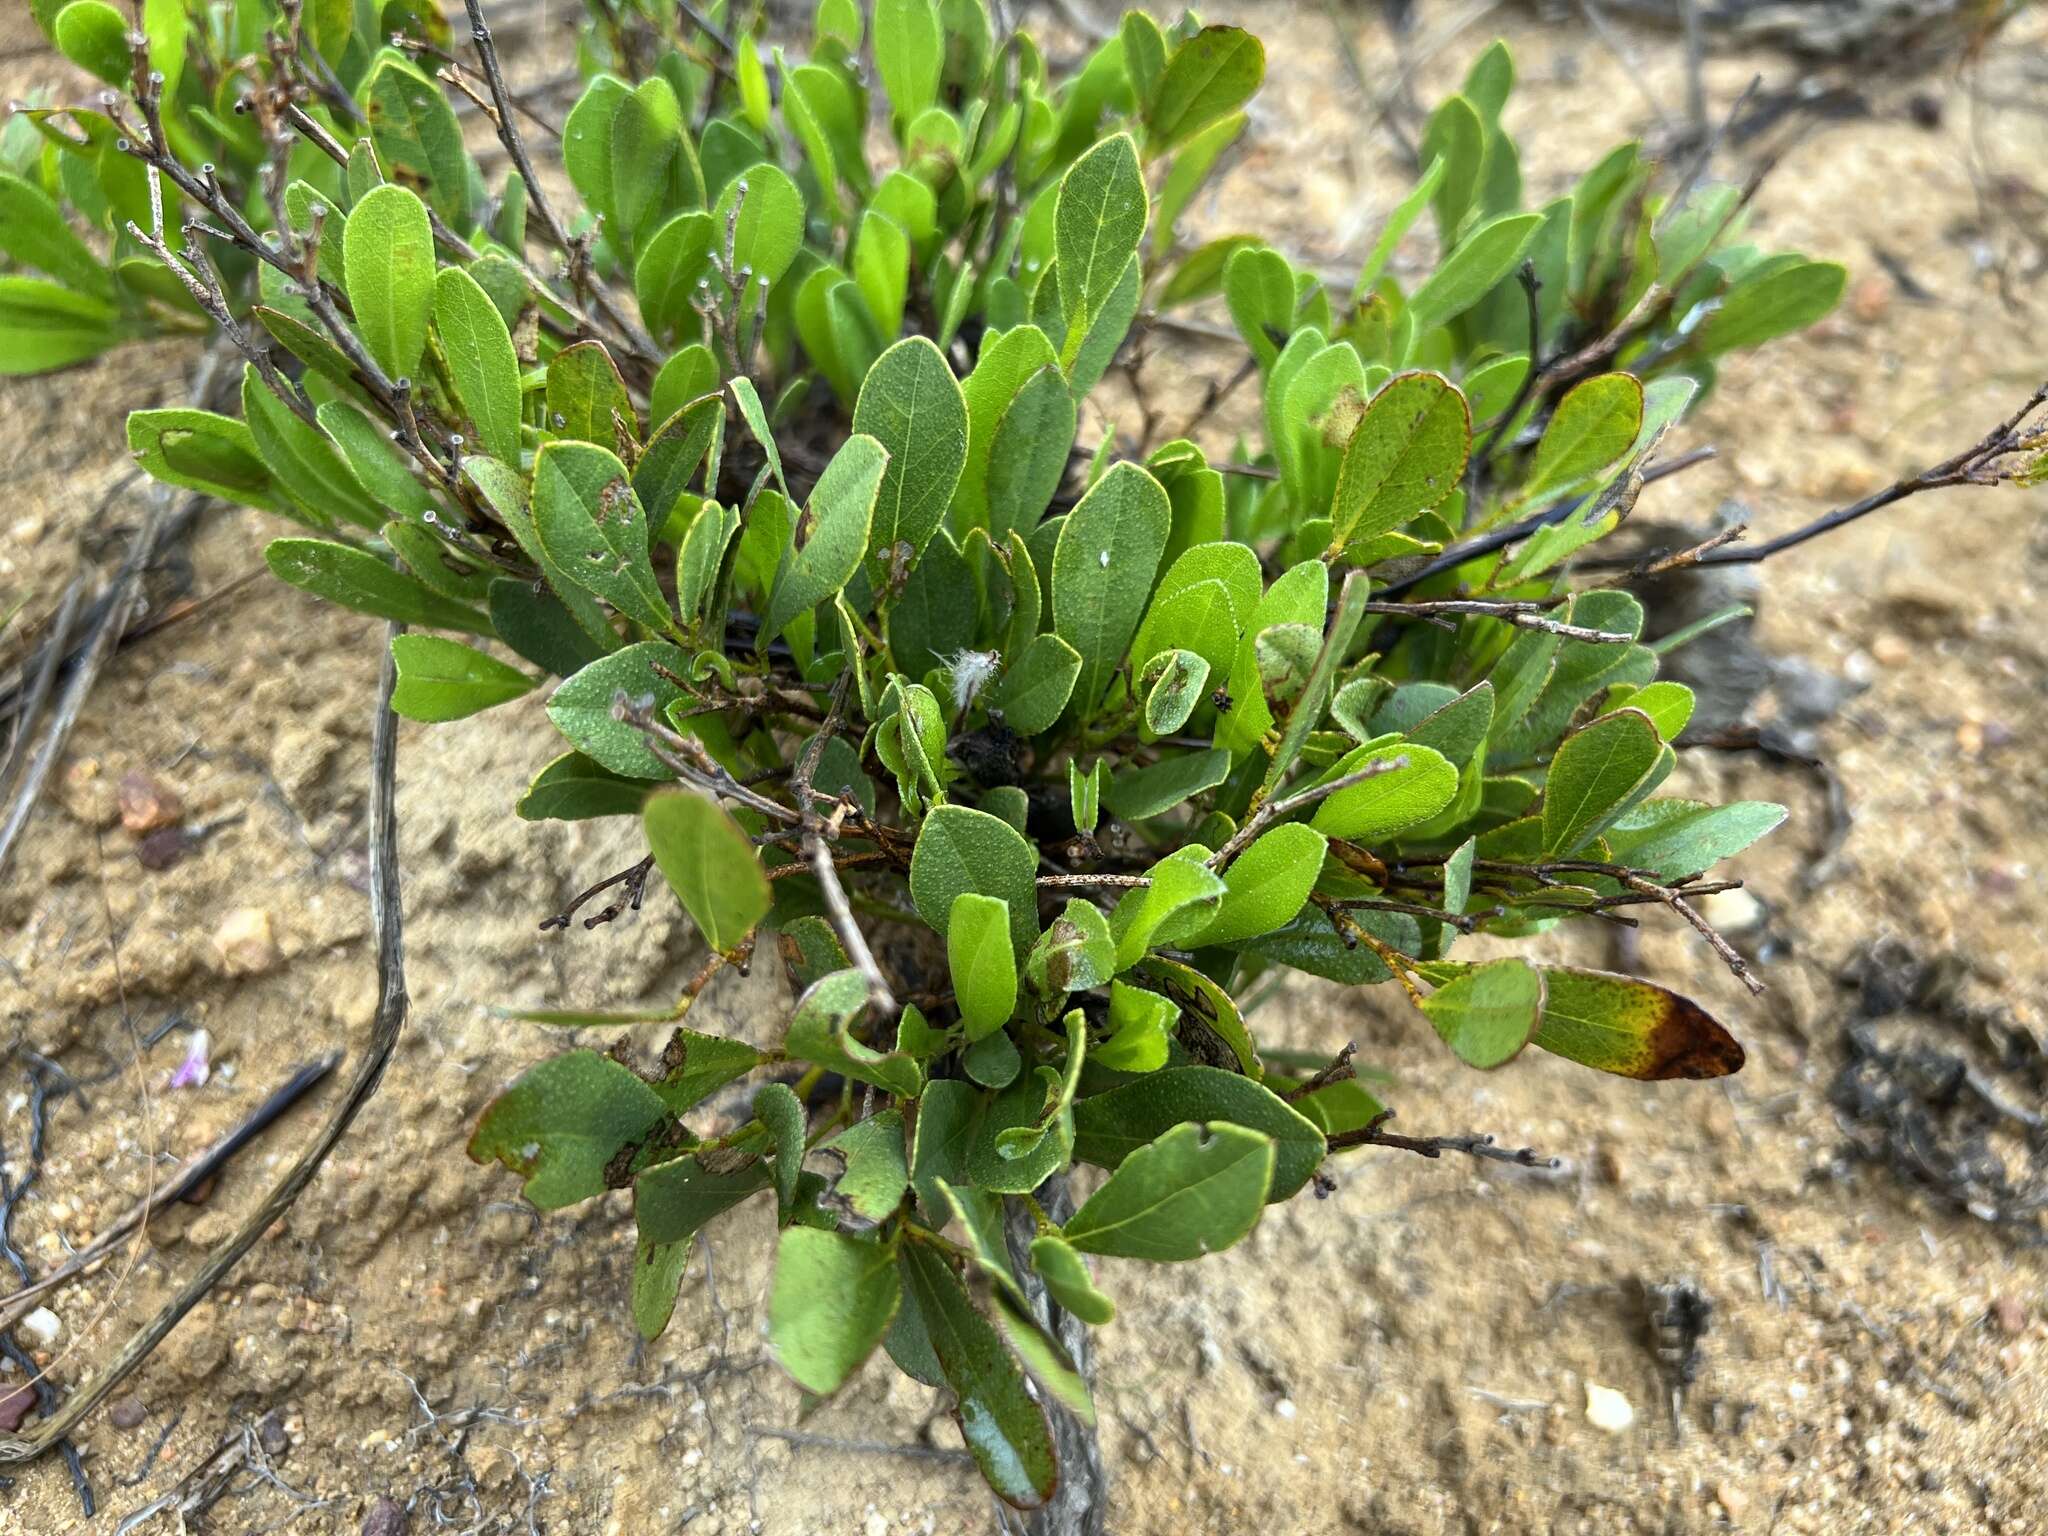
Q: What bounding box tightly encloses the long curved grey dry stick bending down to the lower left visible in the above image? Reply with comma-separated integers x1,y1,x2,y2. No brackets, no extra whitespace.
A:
0,625,408,1464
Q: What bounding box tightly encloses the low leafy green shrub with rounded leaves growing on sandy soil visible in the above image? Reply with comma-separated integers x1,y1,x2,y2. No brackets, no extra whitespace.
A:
0,0,1843,1505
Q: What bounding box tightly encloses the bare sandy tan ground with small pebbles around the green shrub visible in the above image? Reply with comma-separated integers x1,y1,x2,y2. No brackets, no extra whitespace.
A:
0,4,2048,1536
